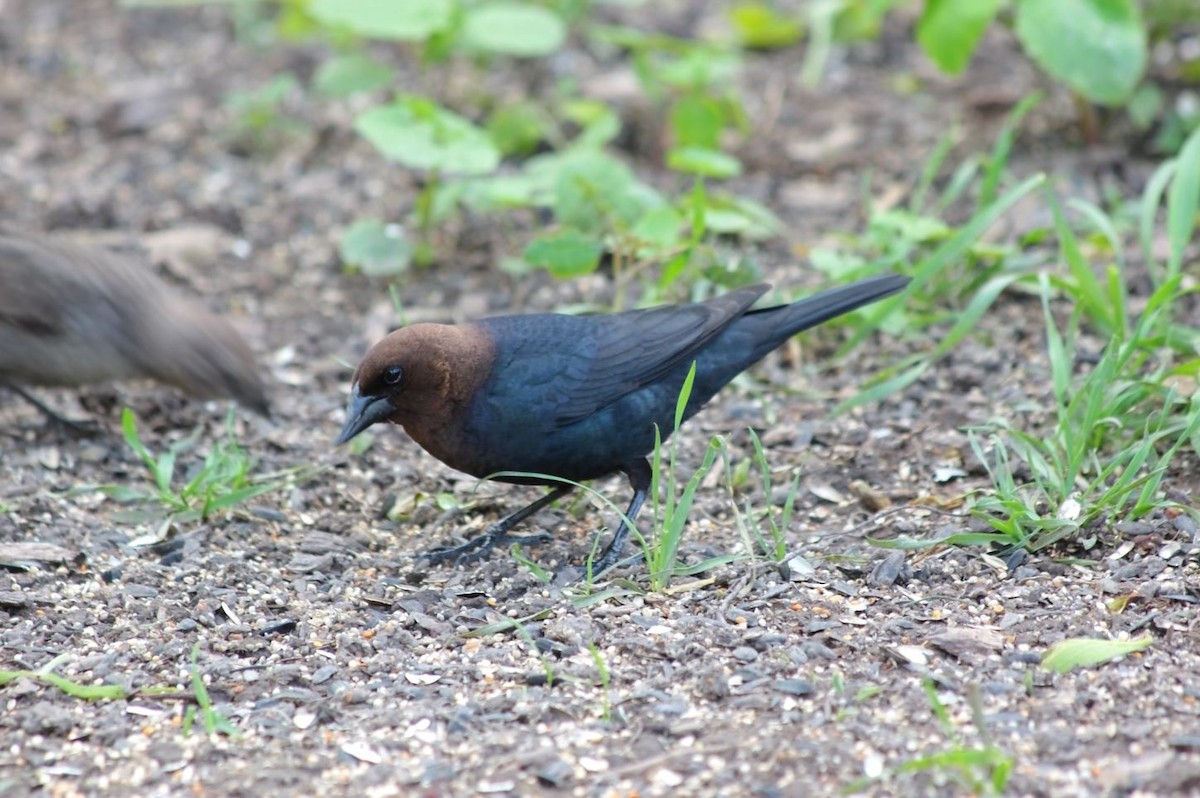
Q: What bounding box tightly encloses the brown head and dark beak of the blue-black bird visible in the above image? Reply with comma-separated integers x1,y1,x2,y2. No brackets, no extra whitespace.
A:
335,324,494,448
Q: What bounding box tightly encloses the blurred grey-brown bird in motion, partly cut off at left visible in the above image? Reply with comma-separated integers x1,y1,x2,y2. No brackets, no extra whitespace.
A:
0,229,269,415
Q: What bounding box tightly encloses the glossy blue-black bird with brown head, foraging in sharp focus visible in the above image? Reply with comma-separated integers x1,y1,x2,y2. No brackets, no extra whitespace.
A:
337,275,908,574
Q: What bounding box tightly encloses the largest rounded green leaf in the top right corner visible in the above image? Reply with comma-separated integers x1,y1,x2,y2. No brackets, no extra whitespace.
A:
1016,0,1146,106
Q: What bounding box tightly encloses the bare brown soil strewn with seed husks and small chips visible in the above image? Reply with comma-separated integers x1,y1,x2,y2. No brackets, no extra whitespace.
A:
0,0,1200,797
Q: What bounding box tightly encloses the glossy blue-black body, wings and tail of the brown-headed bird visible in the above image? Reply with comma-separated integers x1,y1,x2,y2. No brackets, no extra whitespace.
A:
451,277,907,481
